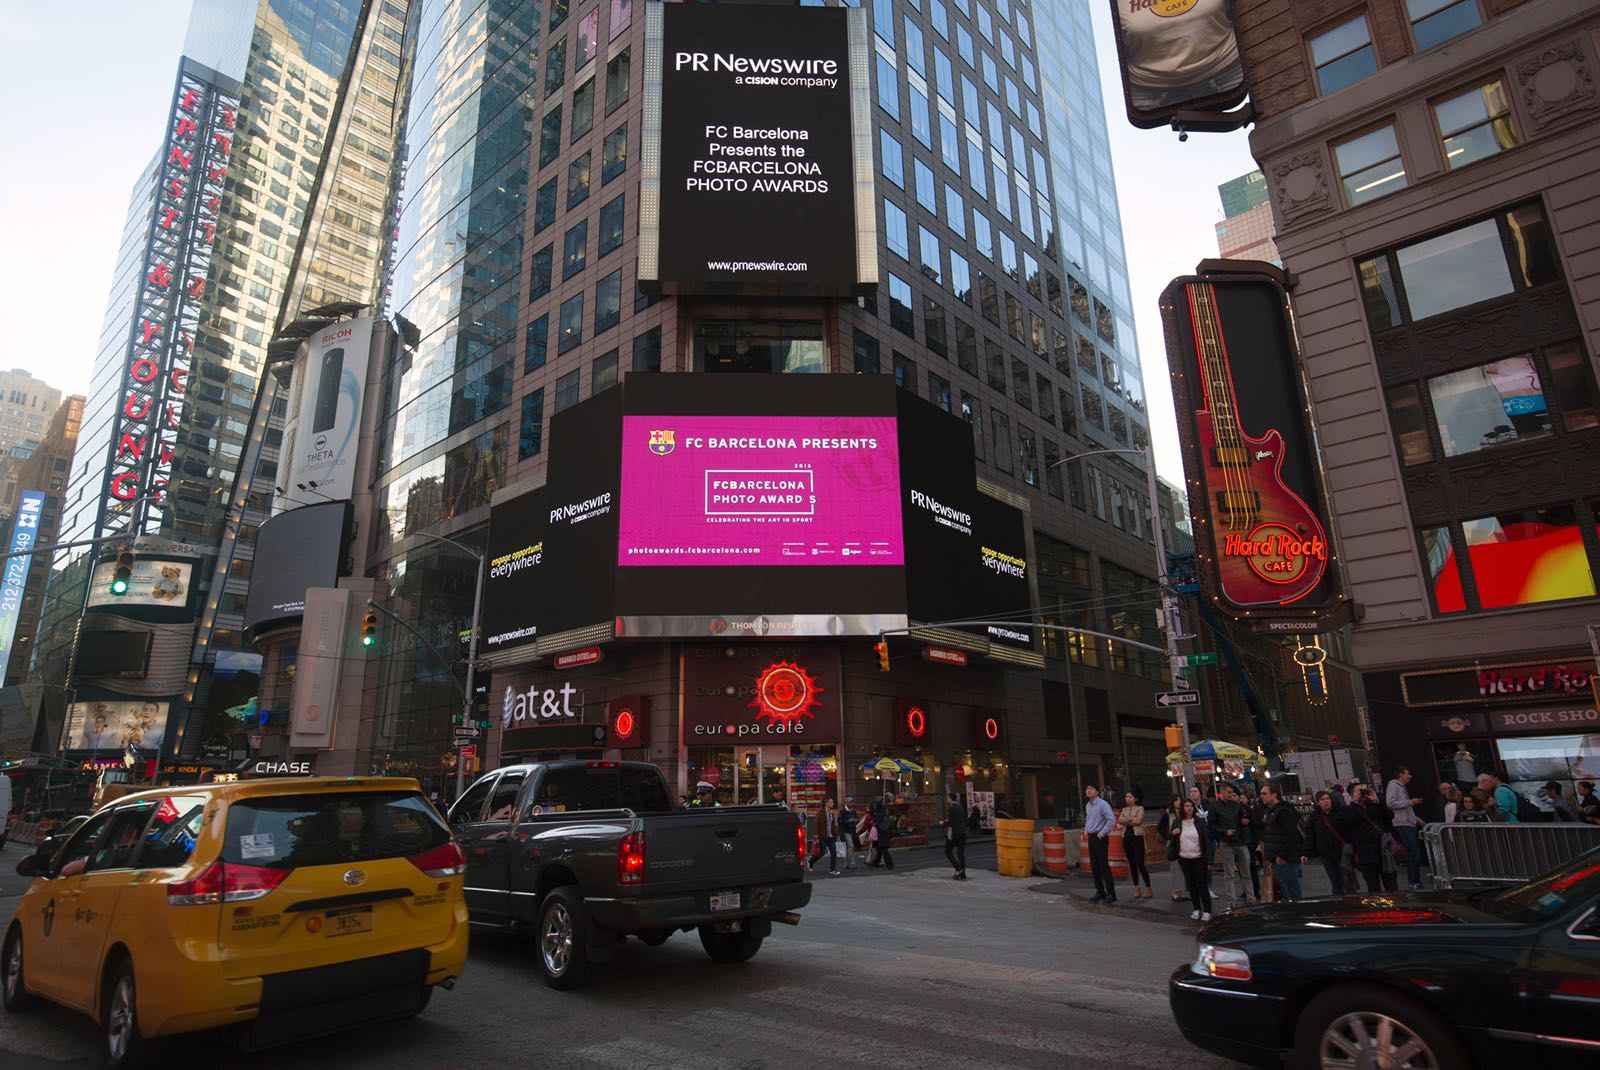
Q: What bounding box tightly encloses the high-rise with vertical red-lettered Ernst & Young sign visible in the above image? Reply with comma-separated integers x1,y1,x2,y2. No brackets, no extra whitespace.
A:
35,0,405,767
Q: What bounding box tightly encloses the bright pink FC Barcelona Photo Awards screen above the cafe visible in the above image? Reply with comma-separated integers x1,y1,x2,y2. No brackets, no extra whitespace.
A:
618,416,906,568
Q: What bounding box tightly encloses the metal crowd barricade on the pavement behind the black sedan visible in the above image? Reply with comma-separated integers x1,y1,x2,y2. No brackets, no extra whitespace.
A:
1422,822,1600,888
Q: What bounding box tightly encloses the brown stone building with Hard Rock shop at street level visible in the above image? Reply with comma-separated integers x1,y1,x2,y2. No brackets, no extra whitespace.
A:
1238,0,1600,808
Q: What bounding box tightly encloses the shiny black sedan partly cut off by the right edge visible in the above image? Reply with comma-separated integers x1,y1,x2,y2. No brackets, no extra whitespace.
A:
1168,849,1600,1070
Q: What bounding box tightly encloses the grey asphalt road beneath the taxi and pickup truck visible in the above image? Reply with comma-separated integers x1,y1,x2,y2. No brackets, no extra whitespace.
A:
0,849,1234,1070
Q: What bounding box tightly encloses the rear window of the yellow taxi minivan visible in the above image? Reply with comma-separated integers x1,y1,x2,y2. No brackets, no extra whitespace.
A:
222,792,450,868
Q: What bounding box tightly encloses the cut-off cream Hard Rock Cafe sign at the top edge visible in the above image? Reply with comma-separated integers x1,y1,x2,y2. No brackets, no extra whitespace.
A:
1110,0,1248,130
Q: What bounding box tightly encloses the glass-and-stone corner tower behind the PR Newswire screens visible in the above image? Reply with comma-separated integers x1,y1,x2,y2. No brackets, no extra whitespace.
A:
358,0,1209,812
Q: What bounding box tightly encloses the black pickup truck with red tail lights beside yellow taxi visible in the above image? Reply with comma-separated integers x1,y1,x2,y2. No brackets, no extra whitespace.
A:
450,761,811,988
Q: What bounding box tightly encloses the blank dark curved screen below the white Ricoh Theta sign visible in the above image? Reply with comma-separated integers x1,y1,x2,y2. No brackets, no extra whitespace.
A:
245,501,350,629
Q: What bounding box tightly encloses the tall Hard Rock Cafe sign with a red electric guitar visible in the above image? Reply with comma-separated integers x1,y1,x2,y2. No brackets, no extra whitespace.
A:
1162,272,1339,632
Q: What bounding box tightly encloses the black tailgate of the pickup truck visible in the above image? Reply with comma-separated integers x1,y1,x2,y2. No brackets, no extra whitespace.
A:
643,806,800,896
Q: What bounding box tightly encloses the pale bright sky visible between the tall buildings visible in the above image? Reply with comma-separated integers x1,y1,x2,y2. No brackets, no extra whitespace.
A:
0,0,1254,483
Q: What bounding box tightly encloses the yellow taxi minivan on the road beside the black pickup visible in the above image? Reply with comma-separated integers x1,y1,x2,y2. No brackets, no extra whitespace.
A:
0,777,467,1068
